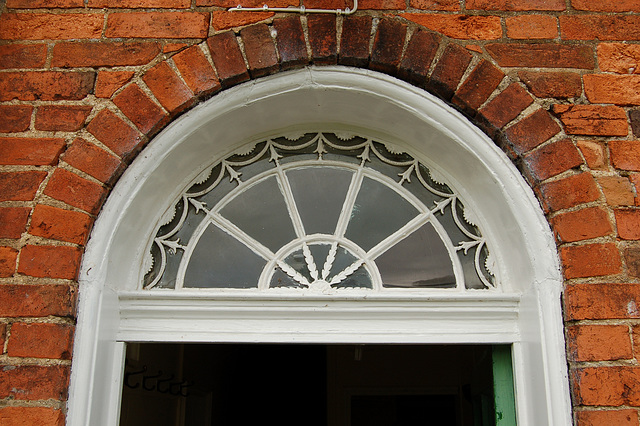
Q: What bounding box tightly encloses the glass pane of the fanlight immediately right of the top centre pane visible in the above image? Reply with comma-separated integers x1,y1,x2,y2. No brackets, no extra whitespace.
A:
345,178,419,251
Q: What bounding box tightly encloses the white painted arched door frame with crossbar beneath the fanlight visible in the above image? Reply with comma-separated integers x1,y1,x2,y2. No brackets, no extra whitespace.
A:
67,67,571,426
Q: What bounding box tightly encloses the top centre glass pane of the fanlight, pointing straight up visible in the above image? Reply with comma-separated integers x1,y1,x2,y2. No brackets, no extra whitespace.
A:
287,167,353,235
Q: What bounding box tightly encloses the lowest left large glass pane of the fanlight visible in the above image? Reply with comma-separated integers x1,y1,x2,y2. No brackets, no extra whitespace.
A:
184,224,266,288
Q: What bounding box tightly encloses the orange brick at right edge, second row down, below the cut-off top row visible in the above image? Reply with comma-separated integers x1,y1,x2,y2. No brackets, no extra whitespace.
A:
559,15,640,41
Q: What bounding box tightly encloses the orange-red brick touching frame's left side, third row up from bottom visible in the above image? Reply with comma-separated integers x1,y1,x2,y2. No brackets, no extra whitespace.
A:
7,323,74,359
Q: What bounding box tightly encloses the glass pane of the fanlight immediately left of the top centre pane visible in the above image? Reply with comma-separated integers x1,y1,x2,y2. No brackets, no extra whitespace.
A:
220,176,296,253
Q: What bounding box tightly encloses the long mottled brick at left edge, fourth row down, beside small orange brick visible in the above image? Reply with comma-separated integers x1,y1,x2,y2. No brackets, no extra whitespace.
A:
0,71,95,101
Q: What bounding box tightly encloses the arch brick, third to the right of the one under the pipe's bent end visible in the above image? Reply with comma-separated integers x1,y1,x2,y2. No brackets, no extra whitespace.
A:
429,43,471,100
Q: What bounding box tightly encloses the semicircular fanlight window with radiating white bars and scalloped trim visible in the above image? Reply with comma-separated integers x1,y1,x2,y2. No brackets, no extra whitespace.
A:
142,132,496,293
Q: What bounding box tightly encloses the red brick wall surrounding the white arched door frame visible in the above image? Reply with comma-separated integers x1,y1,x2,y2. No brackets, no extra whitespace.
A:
0,0,640,426
